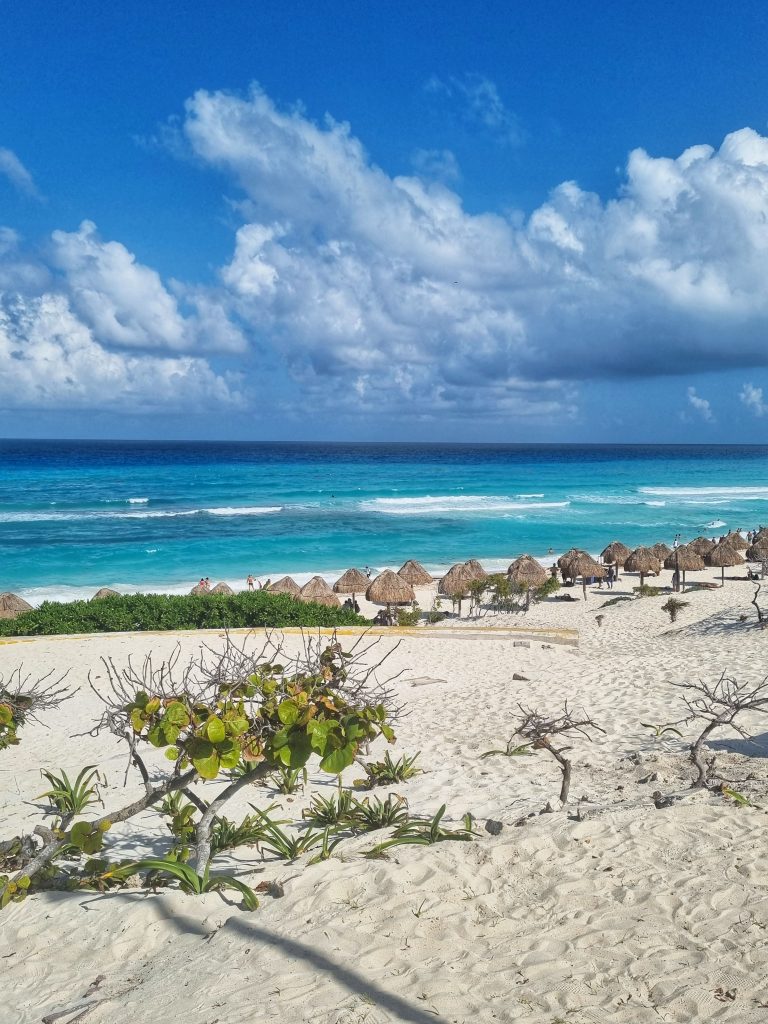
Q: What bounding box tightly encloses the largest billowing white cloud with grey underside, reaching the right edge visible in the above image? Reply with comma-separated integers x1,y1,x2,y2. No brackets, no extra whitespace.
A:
176,87,768,419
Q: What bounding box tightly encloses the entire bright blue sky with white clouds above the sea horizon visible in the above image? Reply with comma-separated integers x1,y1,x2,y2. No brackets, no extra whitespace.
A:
0,0,768,441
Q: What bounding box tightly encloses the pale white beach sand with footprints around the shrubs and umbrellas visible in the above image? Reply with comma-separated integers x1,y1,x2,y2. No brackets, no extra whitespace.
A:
0,570,768,1024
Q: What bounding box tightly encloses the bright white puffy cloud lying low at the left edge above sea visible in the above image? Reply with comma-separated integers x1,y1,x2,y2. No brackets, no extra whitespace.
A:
0,293,243,414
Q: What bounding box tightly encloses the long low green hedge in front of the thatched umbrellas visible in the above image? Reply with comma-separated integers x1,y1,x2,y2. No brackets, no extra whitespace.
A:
0,590,369,636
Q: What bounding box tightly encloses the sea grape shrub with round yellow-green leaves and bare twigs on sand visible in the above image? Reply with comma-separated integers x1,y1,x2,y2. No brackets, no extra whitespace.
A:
0,634,399,898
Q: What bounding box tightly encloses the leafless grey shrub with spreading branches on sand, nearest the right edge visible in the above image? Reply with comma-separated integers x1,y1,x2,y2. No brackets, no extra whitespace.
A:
675,673,768,788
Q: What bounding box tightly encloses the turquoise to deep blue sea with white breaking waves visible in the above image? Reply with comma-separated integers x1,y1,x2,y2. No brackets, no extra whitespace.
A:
0,440,768,603
